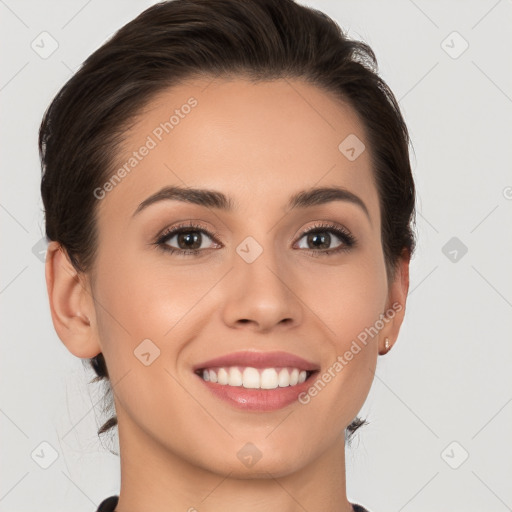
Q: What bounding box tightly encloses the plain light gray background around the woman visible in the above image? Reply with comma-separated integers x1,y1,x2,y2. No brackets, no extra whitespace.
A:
0,0,512,512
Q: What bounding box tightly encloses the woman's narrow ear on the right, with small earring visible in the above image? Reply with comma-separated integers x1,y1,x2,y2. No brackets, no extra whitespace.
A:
379,249,411,355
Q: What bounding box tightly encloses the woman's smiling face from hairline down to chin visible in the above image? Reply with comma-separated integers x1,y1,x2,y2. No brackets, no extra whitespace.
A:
72,79,406,476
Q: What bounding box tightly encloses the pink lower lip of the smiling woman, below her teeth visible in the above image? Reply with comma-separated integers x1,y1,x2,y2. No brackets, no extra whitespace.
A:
197,372,316,411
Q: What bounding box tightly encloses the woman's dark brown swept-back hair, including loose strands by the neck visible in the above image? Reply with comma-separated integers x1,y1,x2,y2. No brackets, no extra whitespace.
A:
39,0,415,446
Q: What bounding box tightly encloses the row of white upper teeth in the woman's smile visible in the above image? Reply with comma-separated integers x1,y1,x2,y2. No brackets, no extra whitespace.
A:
199,366,307,389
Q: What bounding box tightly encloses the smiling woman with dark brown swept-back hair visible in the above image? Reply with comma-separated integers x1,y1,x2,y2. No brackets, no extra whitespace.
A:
39,0,415,512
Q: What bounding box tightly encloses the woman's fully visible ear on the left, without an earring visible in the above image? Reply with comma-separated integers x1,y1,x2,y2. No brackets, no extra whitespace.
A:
45,241,101,358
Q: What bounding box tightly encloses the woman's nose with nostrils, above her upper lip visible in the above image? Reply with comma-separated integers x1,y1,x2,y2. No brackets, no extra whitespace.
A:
222,243,303,333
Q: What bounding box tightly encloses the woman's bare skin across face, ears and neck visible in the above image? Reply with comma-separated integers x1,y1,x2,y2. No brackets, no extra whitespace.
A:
46,78,409,512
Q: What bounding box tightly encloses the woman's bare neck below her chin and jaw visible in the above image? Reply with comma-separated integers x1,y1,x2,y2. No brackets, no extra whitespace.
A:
116,411,353,512
